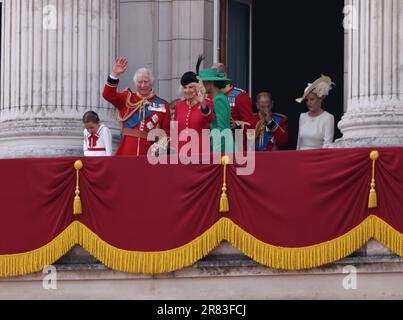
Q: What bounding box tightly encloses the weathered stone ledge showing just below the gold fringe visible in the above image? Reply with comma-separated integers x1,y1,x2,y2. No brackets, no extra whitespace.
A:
0,241,403,282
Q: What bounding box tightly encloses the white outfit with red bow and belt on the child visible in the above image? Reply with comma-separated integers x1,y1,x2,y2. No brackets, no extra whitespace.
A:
83,124,112,157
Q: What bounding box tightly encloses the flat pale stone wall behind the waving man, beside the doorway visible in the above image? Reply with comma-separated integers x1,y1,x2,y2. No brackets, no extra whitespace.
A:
119,0,214,100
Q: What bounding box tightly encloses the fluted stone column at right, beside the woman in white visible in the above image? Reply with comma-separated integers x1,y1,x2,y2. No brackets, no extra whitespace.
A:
334,0,403,147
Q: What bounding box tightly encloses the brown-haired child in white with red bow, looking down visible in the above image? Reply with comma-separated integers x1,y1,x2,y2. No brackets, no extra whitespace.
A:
83,111,112,157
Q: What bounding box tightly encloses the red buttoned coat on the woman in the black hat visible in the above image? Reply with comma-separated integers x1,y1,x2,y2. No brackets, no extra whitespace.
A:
175,100,214,155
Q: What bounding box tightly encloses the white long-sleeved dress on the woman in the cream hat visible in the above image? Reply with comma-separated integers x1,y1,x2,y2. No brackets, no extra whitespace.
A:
297,111,334,150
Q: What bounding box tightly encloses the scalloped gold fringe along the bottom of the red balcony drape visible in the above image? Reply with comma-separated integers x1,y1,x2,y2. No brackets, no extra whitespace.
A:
0,215,403,277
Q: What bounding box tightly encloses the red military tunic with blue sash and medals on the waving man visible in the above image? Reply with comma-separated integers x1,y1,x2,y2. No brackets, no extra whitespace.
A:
103,83,170,156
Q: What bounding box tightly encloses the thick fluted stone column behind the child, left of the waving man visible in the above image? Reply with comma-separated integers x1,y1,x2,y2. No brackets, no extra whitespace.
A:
0,0,118,158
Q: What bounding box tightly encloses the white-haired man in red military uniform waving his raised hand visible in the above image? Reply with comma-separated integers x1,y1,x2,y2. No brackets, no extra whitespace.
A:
103,58,170,156
